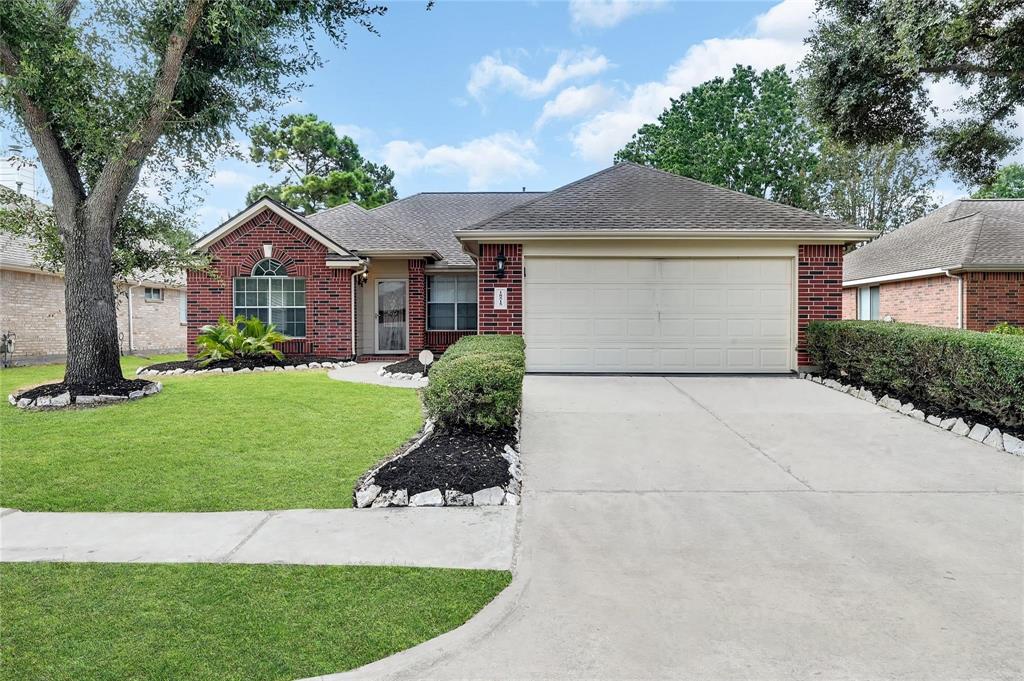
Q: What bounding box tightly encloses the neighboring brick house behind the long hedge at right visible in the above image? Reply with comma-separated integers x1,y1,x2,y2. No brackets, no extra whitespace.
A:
843,199,1024,331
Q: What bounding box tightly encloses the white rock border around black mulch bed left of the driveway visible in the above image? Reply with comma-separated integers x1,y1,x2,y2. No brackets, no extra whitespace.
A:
355,417,522,508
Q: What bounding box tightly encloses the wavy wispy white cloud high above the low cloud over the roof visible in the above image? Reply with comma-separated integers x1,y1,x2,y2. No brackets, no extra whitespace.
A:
466,50,611,99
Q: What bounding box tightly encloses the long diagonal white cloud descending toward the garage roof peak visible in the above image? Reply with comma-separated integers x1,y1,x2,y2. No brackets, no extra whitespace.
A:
572,0,814,163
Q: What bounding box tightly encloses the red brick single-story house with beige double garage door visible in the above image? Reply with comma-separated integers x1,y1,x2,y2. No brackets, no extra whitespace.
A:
188,163,871,373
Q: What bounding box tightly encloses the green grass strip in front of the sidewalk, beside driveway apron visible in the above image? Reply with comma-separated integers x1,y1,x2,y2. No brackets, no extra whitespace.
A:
0,563,510,681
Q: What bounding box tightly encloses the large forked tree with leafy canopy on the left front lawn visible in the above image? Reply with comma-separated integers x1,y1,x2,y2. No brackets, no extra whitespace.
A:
0,0,385,383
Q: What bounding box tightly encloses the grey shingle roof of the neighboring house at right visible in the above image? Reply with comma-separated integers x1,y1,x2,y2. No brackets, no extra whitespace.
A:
843,199,1024,283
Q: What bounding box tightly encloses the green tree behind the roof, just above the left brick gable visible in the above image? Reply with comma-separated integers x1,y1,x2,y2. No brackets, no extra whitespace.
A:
246,114,398,214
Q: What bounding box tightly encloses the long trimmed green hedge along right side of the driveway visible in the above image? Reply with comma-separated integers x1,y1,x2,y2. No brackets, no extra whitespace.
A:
807,322,1024,429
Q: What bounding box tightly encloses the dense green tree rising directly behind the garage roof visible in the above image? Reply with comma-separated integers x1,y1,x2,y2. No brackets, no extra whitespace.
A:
615,66,817,207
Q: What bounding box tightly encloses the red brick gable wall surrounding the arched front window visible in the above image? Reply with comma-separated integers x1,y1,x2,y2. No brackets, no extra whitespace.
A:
188,210,353,357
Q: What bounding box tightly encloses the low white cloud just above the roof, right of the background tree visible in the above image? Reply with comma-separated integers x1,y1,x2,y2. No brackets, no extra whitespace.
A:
382,132,540,189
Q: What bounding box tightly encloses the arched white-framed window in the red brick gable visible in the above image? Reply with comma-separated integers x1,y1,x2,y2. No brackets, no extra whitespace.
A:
234,258,306,338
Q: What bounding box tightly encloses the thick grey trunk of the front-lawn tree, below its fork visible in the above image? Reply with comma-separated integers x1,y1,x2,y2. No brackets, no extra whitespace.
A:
60,204,124,383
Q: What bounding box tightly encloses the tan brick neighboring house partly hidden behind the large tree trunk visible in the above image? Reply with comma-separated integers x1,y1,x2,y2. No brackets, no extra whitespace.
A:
0,235,186,361
